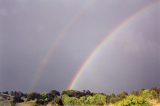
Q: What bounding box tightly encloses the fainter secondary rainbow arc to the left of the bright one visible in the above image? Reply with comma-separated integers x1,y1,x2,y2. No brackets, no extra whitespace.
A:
29,0,96,91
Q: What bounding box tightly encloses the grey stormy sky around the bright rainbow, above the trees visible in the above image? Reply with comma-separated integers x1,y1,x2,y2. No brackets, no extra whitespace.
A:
0,0,160,92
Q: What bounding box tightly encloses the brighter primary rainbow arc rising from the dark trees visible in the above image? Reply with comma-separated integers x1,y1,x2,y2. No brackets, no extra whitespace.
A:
68,0,159,90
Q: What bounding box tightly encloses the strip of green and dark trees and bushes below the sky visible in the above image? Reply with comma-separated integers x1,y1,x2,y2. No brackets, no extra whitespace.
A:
0,87,160,106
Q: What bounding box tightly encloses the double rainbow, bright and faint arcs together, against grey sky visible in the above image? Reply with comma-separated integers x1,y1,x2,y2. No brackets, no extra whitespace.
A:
30,0,160,91
